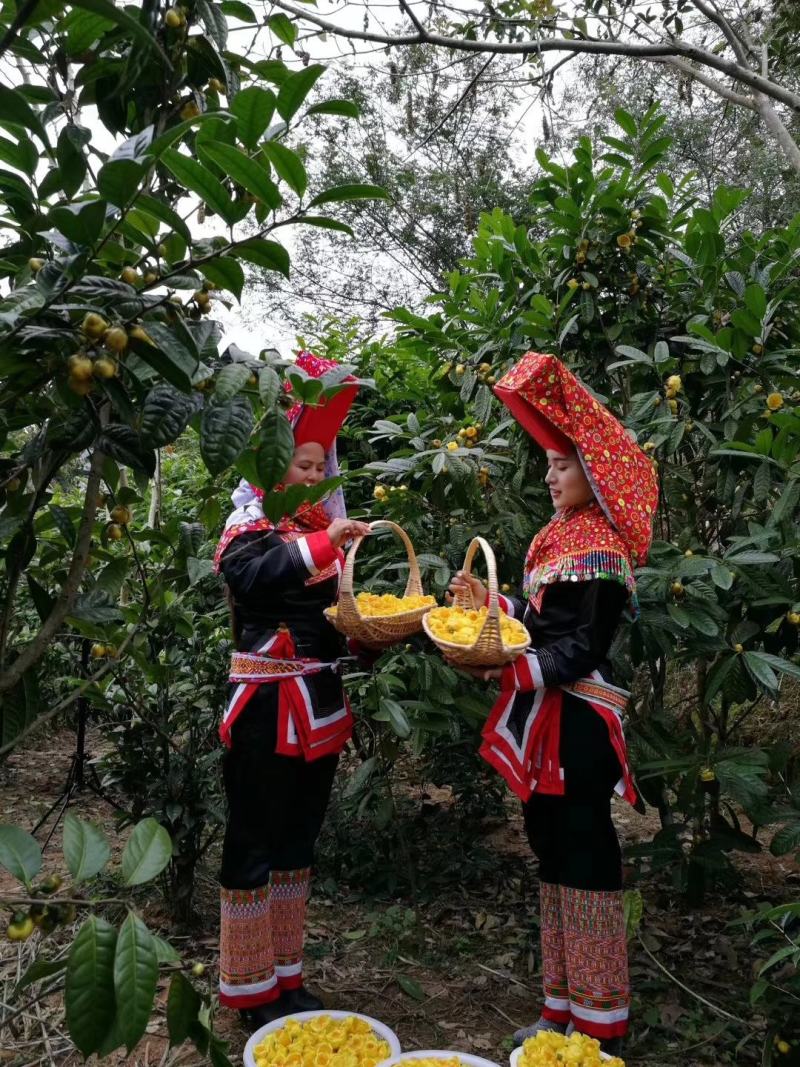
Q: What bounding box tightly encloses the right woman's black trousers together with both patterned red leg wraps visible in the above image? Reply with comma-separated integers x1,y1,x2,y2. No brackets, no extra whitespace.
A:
524,696,629,1039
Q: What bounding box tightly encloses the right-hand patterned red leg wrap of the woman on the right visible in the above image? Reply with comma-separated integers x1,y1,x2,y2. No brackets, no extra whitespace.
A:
561,886,630,1040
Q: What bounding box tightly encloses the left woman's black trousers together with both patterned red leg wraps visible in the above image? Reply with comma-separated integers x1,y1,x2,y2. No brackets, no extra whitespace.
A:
220,686,338,1008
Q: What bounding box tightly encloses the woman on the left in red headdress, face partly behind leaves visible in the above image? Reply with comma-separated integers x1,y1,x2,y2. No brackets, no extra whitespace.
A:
215,352,369,1030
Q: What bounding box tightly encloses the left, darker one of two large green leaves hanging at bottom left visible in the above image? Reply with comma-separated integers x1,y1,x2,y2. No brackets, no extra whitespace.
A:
64,915,116,1056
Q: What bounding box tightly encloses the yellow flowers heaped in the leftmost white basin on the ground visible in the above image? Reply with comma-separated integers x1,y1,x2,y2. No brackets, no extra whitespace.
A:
254,1015,390,1067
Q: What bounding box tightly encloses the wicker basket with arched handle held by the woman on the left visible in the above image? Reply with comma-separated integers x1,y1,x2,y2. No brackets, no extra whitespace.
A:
325,519,434,648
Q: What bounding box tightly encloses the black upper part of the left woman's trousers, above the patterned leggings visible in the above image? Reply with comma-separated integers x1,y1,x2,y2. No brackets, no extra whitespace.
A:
220,685,339,889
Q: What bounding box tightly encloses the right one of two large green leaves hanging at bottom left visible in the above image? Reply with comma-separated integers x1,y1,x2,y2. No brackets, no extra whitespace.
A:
114,913,160,1052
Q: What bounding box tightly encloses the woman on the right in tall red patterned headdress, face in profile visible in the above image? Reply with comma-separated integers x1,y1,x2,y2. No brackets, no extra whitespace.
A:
450,352,658,1054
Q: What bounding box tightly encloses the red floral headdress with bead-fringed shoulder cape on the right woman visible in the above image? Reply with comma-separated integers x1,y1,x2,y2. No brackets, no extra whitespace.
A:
495,352,658,606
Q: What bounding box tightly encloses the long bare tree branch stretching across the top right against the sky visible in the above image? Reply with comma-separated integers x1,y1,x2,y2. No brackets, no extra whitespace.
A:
272,0,800,112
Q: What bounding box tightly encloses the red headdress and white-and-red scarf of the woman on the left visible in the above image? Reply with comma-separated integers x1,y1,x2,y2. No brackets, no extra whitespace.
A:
214,352,358,571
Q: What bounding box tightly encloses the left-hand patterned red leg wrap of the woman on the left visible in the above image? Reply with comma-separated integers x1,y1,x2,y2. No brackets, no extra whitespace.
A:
220,886,279,1008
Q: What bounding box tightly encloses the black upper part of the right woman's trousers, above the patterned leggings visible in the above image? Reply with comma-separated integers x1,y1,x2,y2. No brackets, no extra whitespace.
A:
523,694,622,891
